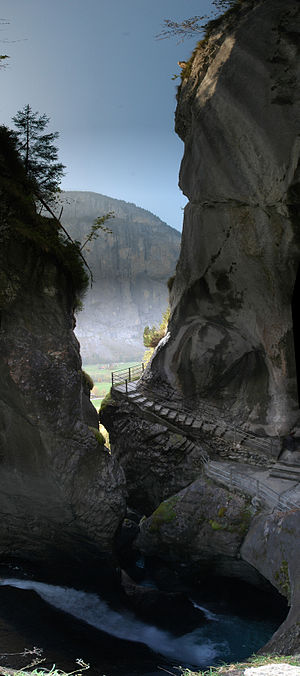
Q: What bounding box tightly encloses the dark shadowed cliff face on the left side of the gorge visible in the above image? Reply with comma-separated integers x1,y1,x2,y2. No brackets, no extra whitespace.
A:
0,235,125,565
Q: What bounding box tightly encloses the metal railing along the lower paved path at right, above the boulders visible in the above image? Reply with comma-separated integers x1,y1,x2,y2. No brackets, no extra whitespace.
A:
205,461,300,510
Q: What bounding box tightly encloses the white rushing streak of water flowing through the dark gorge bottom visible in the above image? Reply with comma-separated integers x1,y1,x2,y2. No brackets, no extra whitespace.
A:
0,578,228,666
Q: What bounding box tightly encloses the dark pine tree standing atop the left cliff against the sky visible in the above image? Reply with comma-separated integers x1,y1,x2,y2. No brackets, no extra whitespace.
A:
12,104,65,200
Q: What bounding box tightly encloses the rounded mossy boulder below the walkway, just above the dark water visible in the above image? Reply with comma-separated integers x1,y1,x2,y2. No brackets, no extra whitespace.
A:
136,478,251,564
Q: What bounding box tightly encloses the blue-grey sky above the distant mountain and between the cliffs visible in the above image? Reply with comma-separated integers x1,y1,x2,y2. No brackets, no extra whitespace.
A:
0,0,216,230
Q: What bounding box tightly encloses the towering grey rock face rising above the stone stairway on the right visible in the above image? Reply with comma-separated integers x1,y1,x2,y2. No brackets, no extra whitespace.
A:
149,0,300,435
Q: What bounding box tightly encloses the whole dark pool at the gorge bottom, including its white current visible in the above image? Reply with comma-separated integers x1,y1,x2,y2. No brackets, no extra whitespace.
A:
0,576,284,676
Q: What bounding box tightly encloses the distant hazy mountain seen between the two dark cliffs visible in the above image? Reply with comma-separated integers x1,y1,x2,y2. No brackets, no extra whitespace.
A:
60,191,181,362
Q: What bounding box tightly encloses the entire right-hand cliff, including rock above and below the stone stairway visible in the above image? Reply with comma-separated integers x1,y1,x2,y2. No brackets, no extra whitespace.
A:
102,0,300,654
